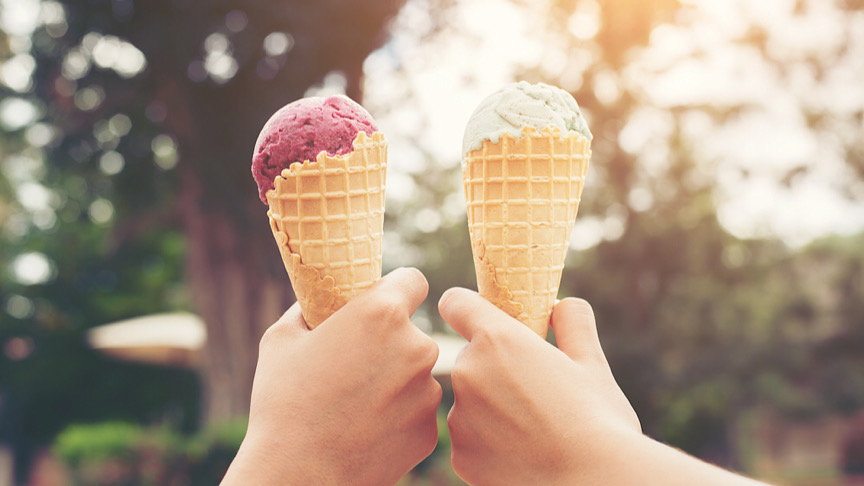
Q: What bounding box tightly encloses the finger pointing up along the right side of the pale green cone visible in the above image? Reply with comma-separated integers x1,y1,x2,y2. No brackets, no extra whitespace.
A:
551,297,605,360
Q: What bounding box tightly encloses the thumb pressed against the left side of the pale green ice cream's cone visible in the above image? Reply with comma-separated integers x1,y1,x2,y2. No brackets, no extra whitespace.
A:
438,287,516,341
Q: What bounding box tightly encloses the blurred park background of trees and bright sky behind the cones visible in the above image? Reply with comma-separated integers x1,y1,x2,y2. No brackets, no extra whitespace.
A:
0,0,864,486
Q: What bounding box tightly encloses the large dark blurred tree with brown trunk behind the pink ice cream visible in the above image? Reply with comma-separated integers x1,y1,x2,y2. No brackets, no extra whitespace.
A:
2,0,402,430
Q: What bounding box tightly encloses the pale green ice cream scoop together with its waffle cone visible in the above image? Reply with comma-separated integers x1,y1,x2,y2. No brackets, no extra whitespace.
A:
462,83,591,337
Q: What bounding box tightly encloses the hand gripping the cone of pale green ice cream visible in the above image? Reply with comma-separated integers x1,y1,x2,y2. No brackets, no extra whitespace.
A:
438,288,642,485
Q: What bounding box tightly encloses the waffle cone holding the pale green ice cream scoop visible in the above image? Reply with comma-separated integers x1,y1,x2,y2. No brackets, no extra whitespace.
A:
462,127,591,337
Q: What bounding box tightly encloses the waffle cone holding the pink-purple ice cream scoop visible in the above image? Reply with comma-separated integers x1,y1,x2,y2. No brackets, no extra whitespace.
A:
266,132,387,329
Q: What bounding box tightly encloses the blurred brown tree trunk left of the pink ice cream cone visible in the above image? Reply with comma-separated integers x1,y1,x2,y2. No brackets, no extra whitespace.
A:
182,163,294,423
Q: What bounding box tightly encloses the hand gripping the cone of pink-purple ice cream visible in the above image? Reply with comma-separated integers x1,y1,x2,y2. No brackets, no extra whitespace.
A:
223,269,441,485
